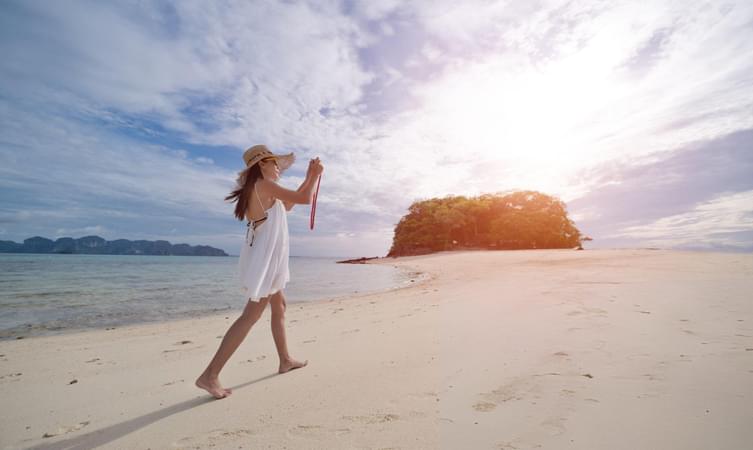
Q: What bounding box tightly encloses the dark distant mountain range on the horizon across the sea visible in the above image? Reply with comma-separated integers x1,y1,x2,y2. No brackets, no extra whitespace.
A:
0,236,228,256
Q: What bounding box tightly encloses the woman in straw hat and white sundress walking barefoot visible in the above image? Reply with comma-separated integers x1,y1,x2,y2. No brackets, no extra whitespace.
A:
196,145,324,398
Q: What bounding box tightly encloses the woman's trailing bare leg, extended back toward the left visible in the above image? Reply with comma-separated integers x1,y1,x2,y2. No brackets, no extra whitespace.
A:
196,297,269,398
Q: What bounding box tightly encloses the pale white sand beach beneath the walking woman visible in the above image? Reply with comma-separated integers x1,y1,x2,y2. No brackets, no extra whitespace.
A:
0,250,753,450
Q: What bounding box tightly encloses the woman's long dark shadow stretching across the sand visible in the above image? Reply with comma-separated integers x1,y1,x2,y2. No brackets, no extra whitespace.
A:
28,373,279,450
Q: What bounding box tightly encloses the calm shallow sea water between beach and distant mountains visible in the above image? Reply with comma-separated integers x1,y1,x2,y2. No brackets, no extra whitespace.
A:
0,253,421,339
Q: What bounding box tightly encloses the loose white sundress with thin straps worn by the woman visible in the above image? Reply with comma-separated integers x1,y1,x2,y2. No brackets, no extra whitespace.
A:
238,185,290,302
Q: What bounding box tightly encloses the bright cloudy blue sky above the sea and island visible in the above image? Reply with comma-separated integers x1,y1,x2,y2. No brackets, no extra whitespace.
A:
0,0,753,257
